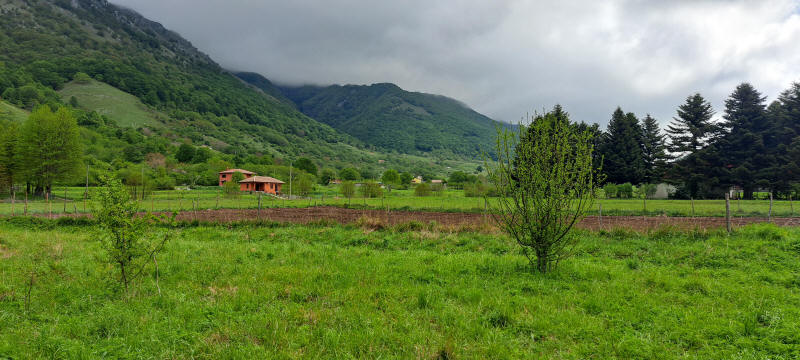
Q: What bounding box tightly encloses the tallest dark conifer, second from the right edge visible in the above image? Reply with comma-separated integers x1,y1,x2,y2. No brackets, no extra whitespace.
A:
715,83,773,199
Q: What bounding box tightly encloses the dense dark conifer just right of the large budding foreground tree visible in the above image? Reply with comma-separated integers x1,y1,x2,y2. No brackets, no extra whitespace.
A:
602,107,644,184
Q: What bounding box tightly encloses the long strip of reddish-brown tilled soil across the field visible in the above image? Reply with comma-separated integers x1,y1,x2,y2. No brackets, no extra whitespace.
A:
37,207,800,231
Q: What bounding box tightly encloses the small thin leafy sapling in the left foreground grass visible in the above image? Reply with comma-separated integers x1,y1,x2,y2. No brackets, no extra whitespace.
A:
93,176,174,292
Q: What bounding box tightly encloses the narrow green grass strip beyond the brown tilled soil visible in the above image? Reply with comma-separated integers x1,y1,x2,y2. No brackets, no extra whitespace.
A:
0,186,800,217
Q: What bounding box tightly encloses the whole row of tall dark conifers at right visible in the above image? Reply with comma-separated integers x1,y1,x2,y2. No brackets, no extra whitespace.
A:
588,83,800,198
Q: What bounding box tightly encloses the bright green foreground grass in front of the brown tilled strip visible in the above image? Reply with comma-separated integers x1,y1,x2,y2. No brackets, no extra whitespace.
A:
0,218,800,359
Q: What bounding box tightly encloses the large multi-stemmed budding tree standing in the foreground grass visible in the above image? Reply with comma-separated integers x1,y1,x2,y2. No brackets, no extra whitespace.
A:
486,107,596,273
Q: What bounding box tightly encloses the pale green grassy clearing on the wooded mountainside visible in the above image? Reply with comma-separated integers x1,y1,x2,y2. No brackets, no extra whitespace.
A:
59,80,164,127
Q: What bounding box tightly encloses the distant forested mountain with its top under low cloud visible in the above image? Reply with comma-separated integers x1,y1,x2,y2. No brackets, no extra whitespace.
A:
237,74,504,158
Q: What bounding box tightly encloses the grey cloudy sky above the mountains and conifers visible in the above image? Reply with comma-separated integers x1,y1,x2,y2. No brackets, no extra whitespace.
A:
112,0,800,125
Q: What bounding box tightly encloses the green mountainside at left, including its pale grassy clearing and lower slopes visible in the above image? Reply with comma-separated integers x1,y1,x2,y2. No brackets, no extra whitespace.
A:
0,0,488,173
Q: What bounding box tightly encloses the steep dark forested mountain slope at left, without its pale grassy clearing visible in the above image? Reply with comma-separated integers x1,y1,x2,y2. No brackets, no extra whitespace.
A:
0,0,363,162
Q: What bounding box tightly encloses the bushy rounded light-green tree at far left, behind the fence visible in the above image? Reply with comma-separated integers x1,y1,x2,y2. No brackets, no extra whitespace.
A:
20,106,83,197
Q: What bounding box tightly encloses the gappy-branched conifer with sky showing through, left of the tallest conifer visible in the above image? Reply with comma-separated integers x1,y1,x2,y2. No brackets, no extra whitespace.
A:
666,93,717,198
